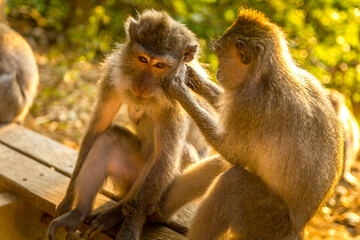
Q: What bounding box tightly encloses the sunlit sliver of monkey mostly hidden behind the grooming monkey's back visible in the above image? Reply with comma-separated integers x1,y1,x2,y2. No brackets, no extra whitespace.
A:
326,89,360,184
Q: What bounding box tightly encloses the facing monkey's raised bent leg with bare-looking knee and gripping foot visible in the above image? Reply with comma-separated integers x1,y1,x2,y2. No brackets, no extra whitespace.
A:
47,126,141,239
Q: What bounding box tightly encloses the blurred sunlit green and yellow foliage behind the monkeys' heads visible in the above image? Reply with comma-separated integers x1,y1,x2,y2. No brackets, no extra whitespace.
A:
7,0,360,115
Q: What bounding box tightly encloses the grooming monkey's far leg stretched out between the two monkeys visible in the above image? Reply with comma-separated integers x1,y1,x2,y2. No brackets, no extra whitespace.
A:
160,155,230,220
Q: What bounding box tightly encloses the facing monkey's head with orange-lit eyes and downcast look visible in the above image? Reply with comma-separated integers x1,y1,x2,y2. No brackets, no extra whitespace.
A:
119,10,198,104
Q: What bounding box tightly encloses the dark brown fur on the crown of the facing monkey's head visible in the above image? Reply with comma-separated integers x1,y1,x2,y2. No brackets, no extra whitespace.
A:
125,9,198,57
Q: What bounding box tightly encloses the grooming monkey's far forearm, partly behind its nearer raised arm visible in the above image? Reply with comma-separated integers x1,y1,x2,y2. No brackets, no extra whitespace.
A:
186,65,223,109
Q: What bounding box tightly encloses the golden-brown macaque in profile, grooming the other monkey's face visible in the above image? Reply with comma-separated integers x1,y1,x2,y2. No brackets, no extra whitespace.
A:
162,9,343,240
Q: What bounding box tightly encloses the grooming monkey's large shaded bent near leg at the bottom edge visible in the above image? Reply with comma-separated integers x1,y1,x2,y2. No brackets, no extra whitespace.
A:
188,166,297,240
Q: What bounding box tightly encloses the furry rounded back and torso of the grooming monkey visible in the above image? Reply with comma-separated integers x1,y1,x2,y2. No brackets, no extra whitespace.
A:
224,71,343,228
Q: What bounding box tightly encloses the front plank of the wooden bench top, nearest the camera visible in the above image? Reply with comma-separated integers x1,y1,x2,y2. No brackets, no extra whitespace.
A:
0,144,184,240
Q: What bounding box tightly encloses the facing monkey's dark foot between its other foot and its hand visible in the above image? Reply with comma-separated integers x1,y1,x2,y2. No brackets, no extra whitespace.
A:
85,204,125,239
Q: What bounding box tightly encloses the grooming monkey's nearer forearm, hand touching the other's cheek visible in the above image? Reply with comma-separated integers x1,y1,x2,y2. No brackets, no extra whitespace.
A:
164,78,237,162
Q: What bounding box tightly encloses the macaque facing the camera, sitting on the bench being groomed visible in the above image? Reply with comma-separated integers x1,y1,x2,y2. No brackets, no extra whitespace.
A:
47,10,212,240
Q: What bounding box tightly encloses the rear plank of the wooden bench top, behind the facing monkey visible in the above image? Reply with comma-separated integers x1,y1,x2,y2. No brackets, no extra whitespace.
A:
0,124,197,233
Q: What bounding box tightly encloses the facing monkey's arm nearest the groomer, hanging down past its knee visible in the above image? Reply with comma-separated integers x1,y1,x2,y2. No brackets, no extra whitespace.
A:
117,106,189,239
